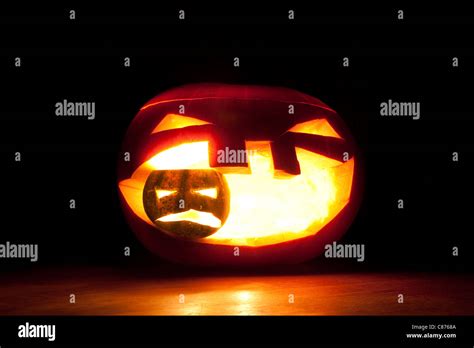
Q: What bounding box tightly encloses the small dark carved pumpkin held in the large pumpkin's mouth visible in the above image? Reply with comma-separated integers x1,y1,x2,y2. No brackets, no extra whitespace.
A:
143,169,230,239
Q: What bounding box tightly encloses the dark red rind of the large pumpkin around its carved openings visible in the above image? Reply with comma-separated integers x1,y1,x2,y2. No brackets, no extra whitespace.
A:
118,84,363,267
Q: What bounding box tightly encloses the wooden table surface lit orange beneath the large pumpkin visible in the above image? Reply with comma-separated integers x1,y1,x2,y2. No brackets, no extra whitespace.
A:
0,266,474,315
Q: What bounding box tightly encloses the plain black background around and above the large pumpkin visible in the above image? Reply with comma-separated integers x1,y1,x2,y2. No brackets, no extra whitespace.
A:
0,3,474,272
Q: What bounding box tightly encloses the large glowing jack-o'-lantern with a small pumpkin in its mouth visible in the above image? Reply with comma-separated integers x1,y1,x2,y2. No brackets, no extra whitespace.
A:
118,84,361,265
